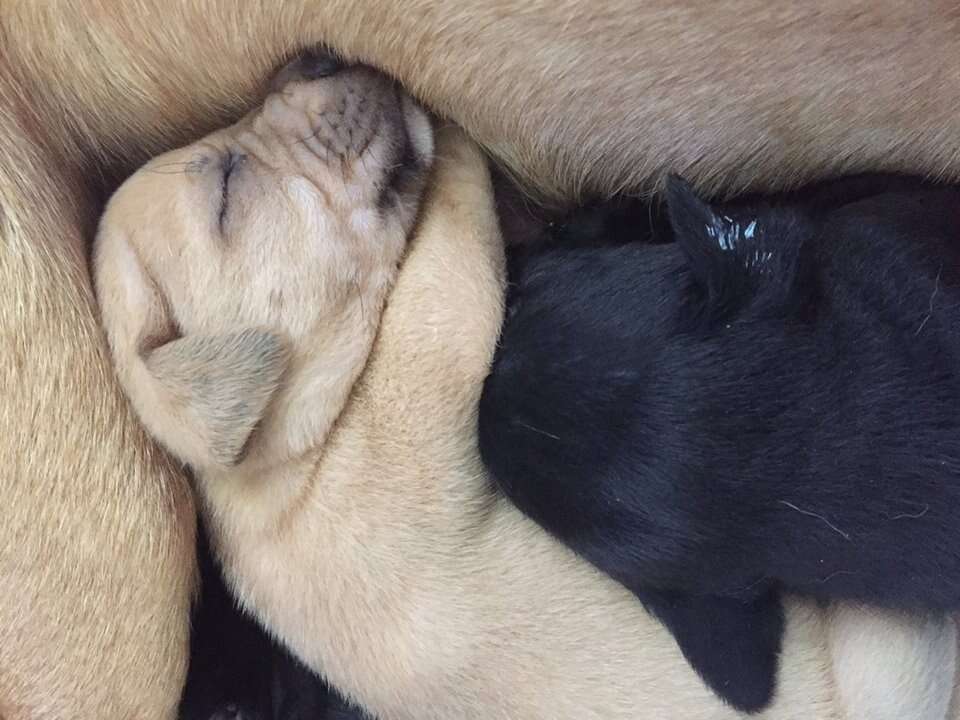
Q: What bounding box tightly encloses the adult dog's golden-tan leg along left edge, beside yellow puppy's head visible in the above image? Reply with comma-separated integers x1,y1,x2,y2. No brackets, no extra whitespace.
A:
0,77,194,720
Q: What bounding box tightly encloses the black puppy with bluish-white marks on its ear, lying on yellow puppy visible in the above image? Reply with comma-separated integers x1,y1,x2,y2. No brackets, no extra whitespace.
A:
480,172,960,711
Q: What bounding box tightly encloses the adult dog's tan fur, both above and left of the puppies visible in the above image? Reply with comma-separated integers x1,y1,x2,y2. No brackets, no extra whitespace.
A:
0,0,960,720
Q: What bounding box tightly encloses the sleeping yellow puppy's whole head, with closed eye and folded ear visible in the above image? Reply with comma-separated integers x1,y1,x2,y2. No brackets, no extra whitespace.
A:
94,56,433,470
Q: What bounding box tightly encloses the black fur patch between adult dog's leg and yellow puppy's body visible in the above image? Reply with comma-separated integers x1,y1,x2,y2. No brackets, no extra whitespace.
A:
179,533,370,720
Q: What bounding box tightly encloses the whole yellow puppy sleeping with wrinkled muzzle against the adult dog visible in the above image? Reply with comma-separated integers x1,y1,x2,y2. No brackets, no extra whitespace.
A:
95,62,949,720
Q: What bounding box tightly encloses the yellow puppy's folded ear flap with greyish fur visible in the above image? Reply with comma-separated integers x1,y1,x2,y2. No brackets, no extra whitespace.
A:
138,329,289,468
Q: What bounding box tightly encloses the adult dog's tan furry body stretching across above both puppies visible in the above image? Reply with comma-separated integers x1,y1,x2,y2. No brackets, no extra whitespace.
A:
0,0,960,195
